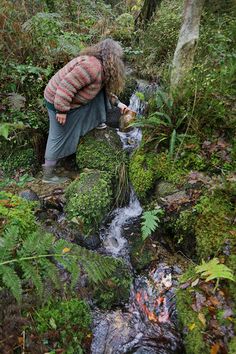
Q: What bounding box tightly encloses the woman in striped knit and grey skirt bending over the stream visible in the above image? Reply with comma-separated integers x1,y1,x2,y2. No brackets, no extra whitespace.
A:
42,39,127,184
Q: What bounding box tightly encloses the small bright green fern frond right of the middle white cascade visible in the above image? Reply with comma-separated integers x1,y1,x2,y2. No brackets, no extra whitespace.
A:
141,206,164,241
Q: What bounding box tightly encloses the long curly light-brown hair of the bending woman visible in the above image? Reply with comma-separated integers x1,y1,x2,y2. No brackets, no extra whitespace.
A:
79,38,125,94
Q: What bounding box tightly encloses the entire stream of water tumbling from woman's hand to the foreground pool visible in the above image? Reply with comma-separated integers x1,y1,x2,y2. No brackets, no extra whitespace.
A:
91,87,184,354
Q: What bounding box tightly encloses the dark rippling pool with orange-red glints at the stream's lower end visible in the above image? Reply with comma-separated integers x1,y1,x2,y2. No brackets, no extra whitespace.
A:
91,264,183,354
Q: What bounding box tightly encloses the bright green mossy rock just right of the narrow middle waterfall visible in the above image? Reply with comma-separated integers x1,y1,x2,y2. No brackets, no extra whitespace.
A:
129,149,157,200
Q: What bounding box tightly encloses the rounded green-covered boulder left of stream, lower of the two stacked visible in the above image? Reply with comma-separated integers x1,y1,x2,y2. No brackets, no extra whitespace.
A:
65,170,112,235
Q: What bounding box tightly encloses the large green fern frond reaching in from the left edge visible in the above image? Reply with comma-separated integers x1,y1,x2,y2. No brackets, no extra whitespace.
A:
0,225,118,302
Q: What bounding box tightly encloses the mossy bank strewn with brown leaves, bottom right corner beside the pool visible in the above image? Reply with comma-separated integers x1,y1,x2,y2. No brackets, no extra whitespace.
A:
177,261,235,354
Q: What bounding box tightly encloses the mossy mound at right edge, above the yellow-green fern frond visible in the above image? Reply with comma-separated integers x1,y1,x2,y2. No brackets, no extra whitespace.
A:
195,191,235,259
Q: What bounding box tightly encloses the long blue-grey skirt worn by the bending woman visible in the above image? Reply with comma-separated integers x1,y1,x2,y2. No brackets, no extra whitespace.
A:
45,90,109,160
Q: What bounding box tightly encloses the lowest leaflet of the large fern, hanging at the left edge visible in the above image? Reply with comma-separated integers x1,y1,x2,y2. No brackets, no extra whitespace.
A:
0,265,22,302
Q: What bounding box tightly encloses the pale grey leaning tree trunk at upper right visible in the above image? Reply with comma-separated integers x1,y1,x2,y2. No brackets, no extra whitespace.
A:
171,0,205,89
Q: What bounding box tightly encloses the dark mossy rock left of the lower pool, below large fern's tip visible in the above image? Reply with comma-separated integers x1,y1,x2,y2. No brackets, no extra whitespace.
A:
93,262,132,309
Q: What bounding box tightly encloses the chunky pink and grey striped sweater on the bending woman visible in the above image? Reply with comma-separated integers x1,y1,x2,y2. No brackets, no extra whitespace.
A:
44,55,103,112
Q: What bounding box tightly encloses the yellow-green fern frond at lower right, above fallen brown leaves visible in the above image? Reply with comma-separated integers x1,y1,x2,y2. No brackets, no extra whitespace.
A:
195,258,235,288
